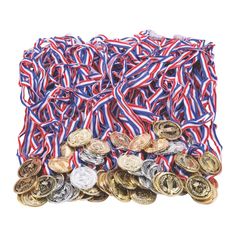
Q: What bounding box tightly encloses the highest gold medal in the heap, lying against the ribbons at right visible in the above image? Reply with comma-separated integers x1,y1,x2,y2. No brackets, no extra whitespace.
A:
153,120,182,140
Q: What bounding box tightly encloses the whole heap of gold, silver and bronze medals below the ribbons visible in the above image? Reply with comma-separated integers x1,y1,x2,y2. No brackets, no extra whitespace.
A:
14,121,221,207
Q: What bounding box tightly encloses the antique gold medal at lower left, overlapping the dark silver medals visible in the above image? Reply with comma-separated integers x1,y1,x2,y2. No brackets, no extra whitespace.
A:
32,175,57,198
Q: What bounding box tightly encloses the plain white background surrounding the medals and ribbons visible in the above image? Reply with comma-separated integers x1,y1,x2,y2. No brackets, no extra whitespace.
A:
0,0,236,236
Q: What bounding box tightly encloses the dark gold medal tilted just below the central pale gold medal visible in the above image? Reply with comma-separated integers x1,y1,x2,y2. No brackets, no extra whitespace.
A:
114,169,137,190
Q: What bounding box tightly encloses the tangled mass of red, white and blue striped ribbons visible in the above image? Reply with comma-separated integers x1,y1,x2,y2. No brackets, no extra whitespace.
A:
17,31,222,182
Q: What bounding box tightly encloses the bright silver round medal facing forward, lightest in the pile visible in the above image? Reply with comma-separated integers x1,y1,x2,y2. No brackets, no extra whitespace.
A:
70,166,97,190
